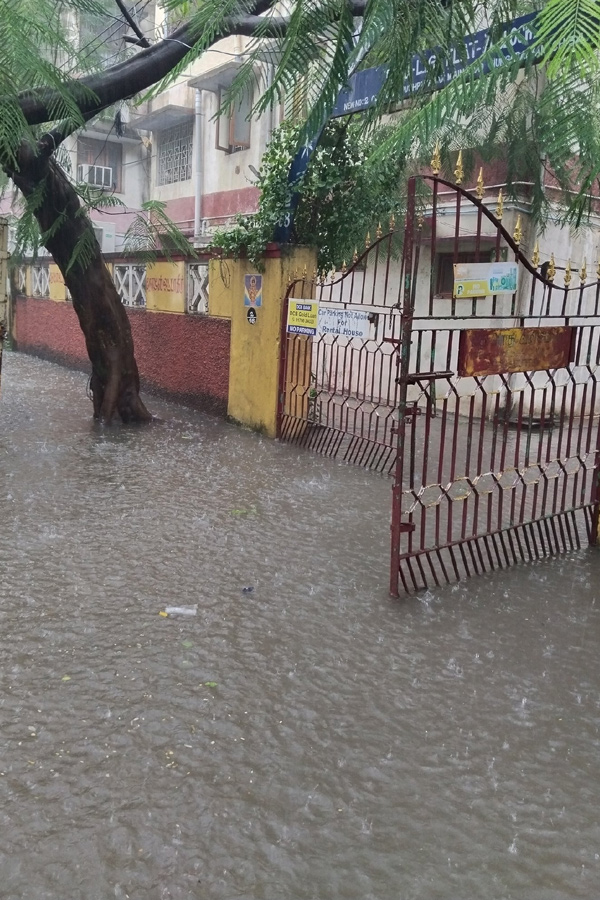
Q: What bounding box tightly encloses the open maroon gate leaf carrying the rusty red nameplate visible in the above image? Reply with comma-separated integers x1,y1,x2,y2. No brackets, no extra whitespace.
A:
390,170,600,596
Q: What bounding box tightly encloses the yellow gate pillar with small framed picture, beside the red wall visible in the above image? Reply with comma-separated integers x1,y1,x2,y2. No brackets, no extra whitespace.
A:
218,247,316,437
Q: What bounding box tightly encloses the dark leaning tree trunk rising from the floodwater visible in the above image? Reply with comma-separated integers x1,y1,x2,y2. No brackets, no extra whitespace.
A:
9,143,152,423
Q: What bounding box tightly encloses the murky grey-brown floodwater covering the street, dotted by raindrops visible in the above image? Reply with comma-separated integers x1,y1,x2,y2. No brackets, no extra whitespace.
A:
0,353,600,900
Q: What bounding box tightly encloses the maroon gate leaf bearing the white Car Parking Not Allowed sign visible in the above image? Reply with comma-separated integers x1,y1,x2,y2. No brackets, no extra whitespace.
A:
278,227,402,474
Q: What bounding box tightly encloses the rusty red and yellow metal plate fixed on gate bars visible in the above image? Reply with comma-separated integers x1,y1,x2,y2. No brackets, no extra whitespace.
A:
458,325,574,375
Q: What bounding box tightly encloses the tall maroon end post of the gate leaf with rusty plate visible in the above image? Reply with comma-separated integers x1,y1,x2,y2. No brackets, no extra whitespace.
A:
390,176,417,597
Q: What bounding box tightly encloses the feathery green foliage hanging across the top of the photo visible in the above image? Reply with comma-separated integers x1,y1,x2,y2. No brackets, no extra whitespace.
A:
0,0,600,232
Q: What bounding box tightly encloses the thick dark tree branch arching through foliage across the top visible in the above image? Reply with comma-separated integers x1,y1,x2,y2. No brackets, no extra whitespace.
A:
19,0,368,125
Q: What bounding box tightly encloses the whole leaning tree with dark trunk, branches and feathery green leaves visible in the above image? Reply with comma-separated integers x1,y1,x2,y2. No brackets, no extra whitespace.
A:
0,0,600,422
